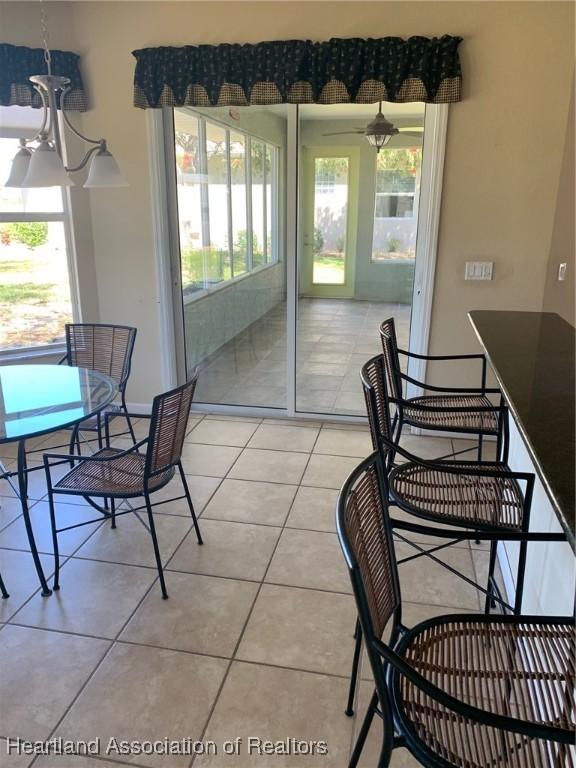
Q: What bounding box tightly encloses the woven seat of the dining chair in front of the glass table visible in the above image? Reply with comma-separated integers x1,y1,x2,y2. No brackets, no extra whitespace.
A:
54,448,175,498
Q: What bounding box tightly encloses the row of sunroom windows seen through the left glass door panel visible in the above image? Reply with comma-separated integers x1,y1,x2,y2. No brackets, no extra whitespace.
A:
174,110,278,295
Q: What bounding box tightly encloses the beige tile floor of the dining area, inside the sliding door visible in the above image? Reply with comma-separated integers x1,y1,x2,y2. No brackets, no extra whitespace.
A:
0,416,487,768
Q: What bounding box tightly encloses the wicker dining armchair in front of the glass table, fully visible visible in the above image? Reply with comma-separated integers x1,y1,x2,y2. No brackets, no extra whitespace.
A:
44,375,202,598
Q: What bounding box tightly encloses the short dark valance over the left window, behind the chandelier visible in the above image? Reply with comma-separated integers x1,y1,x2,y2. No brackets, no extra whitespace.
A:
0,43,87,112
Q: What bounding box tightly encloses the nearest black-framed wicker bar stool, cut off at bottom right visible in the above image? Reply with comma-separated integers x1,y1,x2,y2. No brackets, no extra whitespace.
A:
337,452,576,768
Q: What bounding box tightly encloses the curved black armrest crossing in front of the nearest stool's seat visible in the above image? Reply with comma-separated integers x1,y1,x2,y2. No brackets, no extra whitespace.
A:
373,639,574,744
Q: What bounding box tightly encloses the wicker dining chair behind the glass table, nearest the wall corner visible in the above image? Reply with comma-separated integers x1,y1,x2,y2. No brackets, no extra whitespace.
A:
60,323,139,453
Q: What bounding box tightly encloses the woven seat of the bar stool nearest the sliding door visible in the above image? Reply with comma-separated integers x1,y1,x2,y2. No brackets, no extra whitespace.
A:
404,395,498,434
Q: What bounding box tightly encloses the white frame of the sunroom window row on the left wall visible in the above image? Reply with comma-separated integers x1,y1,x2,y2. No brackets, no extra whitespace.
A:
171,108,281,304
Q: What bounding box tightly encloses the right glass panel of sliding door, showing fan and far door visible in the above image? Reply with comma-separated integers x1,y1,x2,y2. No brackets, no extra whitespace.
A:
296,104,424,416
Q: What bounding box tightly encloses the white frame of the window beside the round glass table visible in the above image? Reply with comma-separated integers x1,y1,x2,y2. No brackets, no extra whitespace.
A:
0,123,82,363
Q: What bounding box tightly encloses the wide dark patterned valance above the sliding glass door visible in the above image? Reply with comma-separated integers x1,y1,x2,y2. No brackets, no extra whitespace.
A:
133,35,462,109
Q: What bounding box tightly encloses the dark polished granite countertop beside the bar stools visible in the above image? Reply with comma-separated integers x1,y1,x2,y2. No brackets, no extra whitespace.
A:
469,310,575,547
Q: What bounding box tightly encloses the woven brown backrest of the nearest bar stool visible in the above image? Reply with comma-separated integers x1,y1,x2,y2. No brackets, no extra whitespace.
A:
337,452,400,642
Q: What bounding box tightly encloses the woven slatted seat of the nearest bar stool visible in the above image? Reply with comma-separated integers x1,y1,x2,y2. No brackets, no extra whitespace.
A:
393,615,576,768
